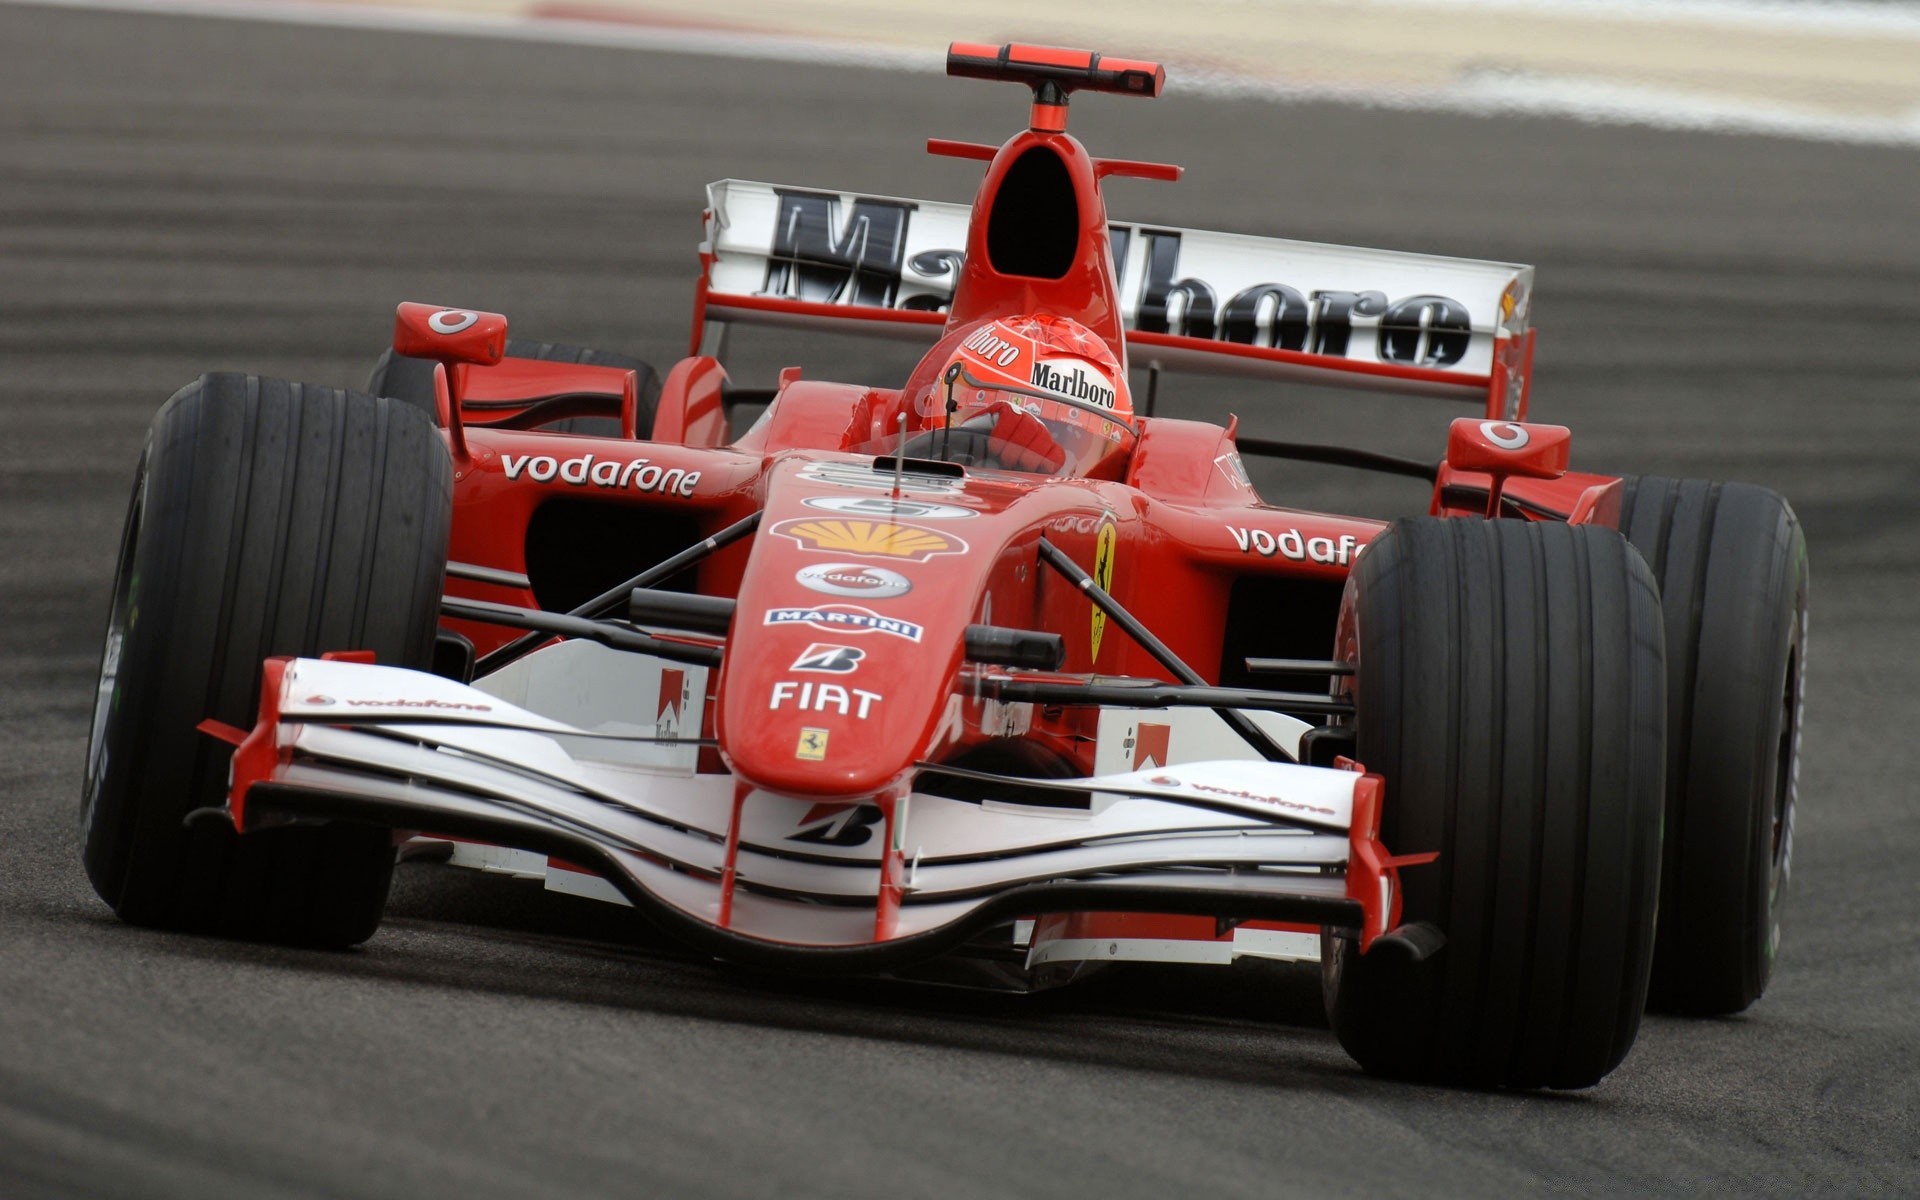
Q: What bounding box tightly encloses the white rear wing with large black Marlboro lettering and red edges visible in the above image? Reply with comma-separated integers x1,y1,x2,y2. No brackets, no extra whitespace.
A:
693,179,1534,420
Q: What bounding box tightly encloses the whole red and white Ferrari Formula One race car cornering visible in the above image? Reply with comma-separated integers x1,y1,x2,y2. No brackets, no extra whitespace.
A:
81,44,1807,1087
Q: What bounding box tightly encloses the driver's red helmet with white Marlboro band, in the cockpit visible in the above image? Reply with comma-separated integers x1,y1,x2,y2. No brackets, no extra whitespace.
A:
935,313,1133,440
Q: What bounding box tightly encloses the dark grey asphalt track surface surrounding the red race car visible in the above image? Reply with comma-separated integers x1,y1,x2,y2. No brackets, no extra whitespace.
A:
0,8,1920,1198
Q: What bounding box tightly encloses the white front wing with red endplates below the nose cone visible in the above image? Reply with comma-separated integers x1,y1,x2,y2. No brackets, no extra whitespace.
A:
207,659,1420,972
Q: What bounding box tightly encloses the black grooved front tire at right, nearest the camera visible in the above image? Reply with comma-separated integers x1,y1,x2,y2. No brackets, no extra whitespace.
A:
1323,518,1665,1087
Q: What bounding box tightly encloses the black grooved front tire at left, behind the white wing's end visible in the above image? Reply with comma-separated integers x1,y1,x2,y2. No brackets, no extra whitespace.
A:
81,374,451,947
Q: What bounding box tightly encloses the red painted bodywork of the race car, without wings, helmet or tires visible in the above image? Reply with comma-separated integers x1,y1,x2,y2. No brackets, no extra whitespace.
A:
378,48,1619,937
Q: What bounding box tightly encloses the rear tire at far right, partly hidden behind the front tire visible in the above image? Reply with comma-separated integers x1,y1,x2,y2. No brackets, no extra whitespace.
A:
1620,476,1807,1016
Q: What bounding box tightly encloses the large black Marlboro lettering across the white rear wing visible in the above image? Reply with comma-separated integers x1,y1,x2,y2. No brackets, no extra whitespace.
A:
760,188,1466,366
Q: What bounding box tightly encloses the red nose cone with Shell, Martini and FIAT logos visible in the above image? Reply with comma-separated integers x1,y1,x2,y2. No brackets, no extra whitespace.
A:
718,463,996,797
